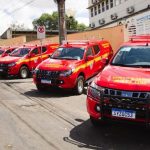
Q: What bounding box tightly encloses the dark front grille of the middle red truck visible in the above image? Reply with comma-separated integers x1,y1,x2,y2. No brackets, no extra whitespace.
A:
36,70,60,80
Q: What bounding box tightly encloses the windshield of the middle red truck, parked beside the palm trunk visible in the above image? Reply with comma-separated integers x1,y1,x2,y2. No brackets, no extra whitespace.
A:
51,47,84,60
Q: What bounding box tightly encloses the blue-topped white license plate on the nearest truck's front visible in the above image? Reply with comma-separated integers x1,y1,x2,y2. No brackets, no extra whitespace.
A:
112,108,136,119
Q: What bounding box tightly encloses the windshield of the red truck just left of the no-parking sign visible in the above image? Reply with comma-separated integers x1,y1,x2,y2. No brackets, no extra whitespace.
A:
10,48,30,57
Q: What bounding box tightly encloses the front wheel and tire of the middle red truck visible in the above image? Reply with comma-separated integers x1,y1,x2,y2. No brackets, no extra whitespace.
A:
75,76,84,95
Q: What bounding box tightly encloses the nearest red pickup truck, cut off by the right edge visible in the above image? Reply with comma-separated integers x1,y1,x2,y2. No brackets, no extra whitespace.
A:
87,36,150,125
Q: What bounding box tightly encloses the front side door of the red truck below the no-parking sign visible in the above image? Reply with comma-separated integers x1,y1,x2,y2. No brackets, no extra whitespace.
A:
30,47,42,69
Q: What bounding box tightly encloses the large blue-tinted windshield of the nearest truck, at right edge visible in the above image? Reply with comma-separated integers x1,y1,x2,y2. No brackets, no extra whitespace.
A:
111,46,150,68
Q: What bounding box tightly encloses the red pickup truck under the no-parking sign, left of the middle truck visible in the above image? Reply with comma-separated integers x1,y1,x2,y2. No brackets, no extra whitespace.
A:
0,44,58,78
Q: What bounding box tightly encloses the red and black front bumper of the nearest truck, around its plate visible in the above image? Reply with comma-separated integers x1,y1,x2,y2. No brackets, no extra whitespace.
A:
87,86,150,125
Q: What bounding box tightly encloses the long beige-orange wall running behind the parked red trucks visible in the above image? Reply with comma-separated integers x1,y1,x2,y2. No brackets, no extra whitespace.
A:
0,26,124,51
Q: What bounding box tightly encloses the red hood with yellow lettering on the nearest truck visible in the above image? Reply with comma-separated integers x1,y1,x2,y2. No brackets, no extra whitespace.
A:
96,65,150,91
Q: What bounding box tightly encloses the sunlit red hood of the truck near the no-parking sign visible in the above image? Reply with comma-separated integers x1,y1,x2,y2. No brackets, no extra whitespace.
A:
0,56,20,64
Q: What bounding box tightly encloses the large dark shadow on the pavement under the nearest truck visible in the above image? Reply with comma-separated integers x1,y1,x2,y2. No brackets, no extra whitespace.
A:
63,120,150,150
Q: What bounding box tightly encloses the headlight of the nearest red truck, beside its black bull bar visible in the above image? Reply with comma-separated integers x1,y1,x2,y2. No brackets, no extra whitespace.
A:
88,81,104,100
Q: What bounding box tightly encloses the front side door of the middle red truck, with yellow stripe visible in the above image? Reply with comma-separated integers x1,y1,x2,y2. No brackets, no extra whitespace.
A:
85,47,94,78
